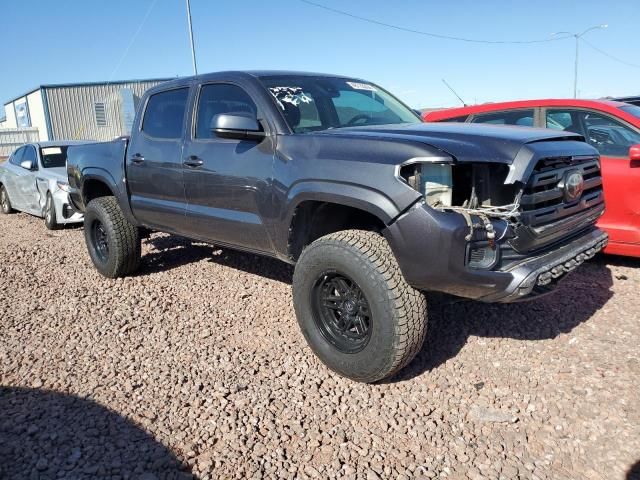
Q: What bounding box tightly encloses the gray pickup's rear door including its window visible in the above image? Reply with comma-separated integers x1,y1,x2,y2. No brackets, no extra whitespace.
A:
126,86,189,233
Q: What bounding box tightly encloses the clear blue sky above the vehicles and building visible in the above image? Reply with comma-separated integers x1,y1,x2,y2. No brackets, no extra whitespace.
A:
0,0,640,115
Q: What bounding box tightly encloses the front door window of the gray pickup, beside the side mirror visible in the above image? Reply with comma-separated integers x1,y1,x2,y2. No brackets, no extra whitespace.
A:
196,83,258,138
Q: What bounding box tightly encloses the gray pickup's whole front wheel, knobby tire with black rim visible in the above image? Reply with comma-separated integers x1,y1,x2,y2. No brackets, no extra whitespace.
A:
293,230,427,382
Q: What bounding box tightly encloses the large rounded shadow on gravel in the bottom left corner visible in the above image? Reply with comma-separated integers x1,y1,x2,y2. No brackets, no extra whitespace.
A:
0,387,193,480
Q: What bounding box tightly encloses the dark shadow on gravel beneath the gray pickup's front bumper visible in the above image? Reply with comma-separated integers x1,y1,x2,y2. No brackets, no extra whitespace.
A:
391,259,613,382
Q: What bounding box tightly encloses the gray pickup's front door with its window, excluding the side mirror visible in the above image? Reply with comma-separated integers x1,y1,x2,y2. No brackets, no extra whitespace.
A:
183,83,274,252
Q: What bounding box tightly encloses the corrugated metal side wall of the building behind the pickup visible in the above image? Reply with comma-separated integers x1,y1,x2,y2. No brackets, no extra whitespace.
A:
46,81,169,140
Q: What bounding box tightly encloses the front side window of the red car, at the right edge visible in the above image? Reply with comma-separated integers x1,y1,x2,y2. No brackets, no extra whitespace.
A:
582,112,640,158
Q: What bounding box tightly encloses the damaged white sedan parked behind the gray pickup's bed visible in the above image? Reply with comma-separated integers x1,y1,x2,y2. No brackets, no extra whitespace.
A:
0,141,83,230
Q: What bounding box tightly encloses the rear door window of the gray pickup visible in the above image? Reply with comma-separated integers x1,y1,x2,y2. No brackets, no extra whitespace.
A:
142,88,189,139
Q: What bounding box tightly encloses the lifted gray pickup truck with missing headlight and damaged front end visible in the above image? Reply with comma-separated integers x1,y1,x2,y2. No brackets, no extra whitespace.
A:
68,72,607,382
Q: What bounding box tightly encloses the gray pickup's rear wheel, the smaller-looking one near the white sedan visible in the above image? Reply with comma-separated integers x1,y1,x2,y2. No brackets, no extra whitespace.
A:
84,197,141,278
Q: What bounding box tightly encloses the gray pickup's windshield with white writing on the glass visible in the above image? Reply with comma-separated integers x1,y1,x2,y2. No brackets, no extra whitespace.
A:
260,75,421,133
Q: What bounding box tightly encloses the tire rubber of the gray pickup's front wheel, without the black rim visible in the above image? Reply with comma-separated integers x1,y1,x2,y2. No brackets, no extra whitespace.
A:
293,230,427,383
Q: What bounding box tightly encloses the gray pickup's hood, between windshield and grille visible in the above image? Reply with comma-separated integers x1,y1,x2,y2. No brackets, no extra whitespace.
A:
320,123,586,165
